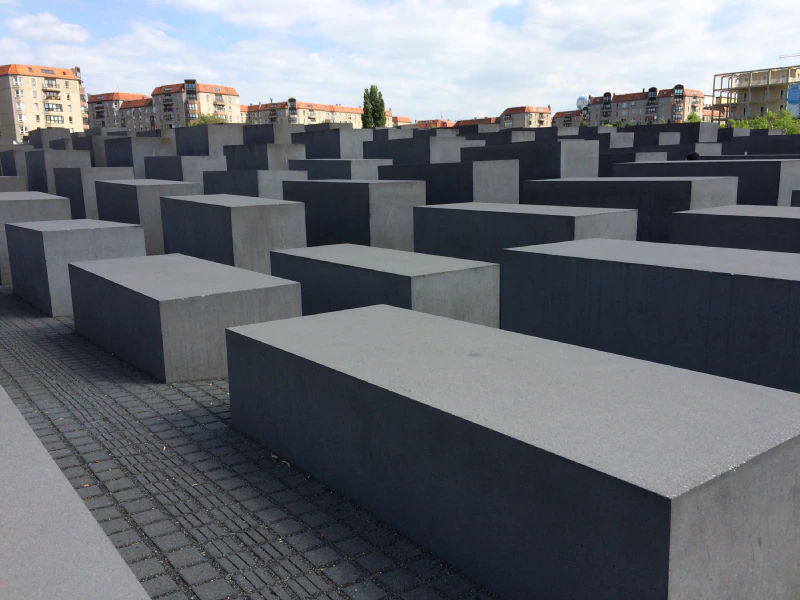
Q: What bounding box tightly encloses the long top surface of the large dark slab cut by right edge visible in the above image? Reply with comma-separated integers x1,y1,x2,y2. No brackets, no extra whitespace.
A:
511,238,800,281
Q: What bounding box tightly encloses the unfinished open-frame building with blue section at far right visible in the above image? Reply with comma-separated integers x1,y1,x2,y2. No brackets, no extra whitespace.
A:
712,65,800,122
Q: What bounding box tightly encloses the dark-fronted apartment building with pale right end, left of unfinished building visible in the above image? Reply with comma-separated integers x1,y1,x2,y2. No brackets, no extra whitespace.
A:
582,85,705,127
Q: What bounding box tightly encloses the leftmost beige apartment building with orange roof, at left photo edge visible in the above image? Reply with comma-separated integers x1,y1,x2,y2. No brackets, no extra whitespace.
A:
0,64,87,144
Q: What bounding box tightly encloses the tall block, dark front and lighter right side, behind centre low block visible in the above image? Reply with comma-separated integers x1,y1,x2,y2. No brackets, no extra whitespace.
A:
283,179,425,250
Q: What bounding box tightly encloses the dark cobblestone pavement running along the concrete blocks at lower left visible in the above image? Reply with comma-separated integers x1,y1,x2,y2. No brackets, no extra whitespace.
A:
0,288,490,600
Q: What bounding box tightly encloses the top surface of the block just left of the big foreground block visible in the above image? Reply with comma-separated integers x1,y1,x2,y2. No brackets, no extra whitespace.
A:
73,254,294,301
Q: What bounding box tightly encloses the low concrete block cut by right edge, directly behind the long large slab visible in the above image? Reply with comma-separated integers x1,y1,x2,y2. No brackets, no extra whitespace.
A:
670,205,800,252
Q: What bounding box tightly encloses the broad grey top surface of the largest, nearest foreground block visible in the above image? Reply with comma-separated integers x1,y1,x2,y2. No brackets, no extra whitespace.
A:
234,306,800,498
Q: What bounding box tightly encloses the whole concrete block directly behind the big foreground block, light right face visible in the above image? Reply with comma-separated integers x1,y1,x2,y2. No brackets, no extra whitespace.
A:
272,244,500,327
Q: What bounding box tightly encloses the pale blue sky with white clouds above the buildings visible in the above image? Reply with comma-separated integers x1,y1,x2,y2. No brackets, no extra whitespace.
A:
0,0,800,120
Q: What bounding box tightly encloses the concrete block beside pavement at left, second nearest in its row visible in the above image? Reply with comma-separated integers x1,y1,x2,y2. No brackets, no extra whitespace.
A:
6,219,145,317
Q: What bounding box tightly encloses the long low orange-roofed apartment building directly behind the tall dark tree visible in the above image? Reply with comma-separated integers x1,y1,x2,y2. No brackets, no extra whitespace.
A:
242,98,394,129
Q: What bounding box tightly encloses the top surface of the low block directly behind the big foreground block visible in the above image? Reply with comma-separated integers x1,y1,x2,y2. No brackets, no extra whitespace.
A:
273,244,492,277
